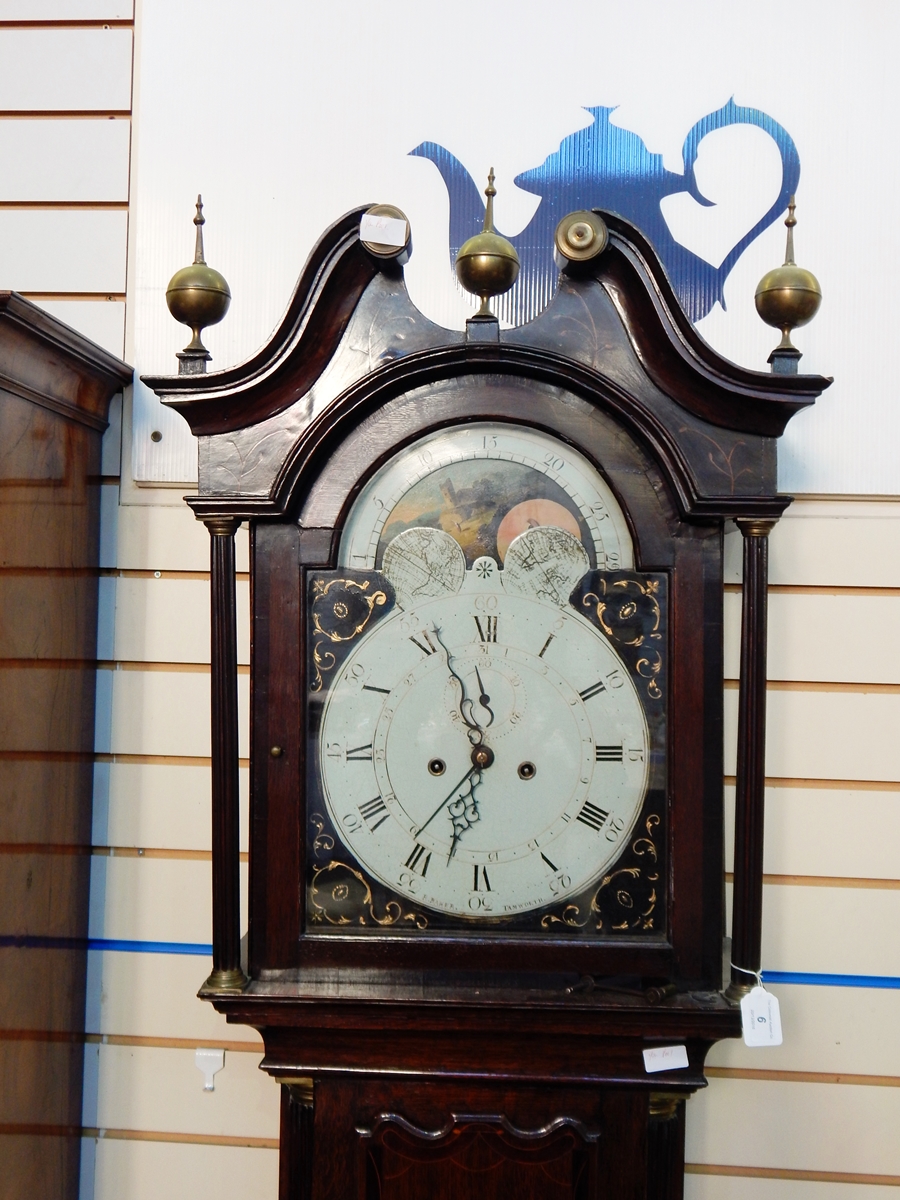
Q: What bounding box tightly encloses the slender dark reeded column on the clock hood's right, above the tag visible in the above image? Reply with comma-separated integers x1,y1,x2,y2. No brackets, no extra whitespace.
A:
726,520,775,1000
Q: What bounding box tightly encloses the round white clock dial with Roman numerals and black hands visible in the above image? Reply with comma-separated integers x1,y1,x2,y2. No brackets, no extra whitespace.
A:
319,552,649,918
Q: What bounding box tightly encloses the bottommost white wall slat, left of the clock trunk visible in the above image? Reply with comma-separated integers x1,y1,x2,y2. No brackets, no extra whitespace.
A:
94,1139,278,1200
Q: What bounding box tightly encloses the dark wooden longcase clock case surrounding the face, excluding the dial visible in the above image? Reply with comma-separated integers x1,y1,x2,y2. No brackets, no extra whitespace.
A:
146,210,827,1200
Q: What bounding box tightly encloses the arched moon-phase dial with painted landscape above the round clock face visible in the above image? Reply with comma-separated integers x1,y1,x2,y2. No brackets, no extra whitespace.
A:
338,421,634,570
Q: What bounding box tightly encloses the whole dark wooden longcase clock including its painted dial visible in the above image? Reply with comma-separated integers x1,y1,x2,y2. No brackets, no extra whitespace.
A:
148,211,827,1200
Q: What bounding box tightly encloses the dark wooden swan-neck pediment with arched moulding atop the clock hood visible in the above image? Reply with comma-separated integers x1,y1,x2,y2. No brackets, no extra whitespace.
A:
145,209,830,520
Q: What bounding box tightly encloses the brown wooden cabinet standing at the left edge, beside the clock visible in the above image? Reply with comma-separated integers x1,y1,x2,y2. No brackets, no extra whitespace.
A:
0,292,132,1200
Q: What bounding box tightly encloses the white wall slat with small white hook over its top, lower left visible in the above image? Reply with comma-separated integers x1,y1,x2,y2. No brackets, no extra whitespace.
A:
97,1045,281,1138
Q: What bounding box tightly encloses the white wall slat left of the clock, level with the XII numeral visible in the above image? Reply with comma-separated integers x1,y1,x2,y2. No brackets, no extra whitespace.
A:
115,573,250,664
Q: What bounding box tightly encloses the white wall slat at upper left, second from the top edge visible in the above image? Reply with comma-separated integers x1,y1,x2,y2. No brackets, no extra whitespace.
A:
0,28,132,112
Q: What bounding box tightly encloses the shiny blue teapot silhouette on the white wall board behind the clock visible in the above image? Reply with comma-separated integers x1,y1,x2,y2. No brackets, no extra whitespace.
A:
410,100,800,325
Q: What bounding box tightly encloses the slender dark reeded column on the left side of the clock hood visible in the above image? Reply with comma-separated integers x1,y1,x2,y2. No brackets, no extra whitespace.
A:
202,517,247,992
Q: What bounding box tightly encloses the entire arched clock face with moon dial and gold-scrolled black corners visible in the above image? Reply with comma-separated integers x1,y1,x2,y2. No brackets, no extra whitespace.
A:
307,425,666,936
